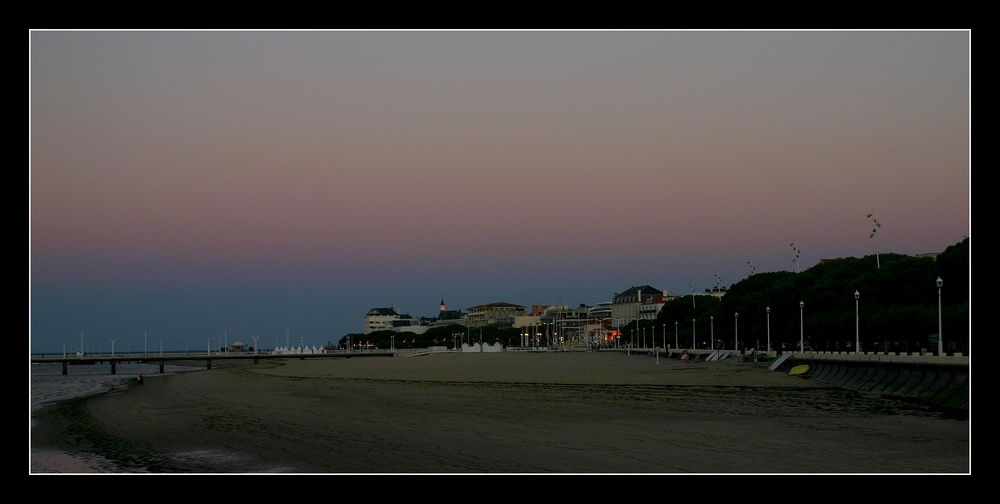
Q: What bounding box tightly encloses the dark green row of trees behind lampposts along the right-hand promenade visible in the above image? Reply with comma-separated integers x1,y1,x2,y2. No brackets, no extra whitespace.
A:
640,238,969,355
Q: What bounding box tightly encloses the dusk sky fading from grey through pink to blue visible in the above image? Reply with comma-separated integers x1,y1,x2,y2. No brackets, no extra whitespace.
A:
29,31,971,353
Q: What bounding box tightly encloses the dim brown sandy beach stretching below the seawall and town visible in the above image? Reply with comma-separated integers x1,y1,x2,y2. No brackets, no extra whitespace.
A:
31,352,970,474
